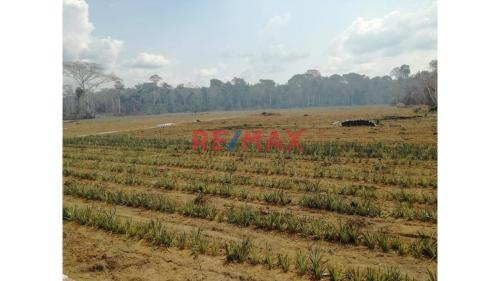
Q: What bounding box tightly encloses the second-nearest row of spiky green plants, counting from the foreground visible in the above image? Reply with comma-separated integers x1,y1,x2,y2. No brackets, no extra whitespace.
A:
64,184,437,258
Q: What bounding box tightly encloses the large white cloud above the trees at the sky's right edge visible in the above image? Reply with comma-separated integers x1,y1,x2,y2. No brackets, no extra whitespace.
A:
325,3,437,75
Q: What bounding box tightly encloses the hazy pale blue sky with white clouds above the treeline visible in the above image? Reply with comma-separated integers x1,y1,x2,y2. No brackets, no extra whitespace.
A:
63,0,437,86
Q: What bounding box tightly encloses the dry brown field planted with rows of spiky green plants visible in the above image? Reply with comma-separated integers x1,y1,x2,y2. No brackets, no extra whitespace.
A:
63,107,437,281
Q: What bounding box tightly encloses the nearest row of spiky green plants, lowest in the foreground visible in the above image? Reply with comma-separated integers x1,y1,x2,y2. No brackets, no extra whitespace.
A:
63,203,430,281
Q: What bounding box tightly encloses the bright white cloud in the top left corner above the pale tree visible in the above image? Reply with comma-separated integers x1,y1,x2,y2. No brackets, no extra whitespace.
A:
63,0,123,66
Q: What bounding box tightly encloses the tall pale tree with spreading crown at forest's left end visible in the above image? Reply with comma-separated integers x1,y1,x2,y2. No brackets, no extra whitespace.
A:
63,61,119,118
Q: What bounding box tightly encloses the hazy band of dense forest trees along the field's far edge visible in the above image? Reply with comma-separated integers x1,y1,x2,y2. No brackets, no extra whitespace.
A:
63,60,437,119
